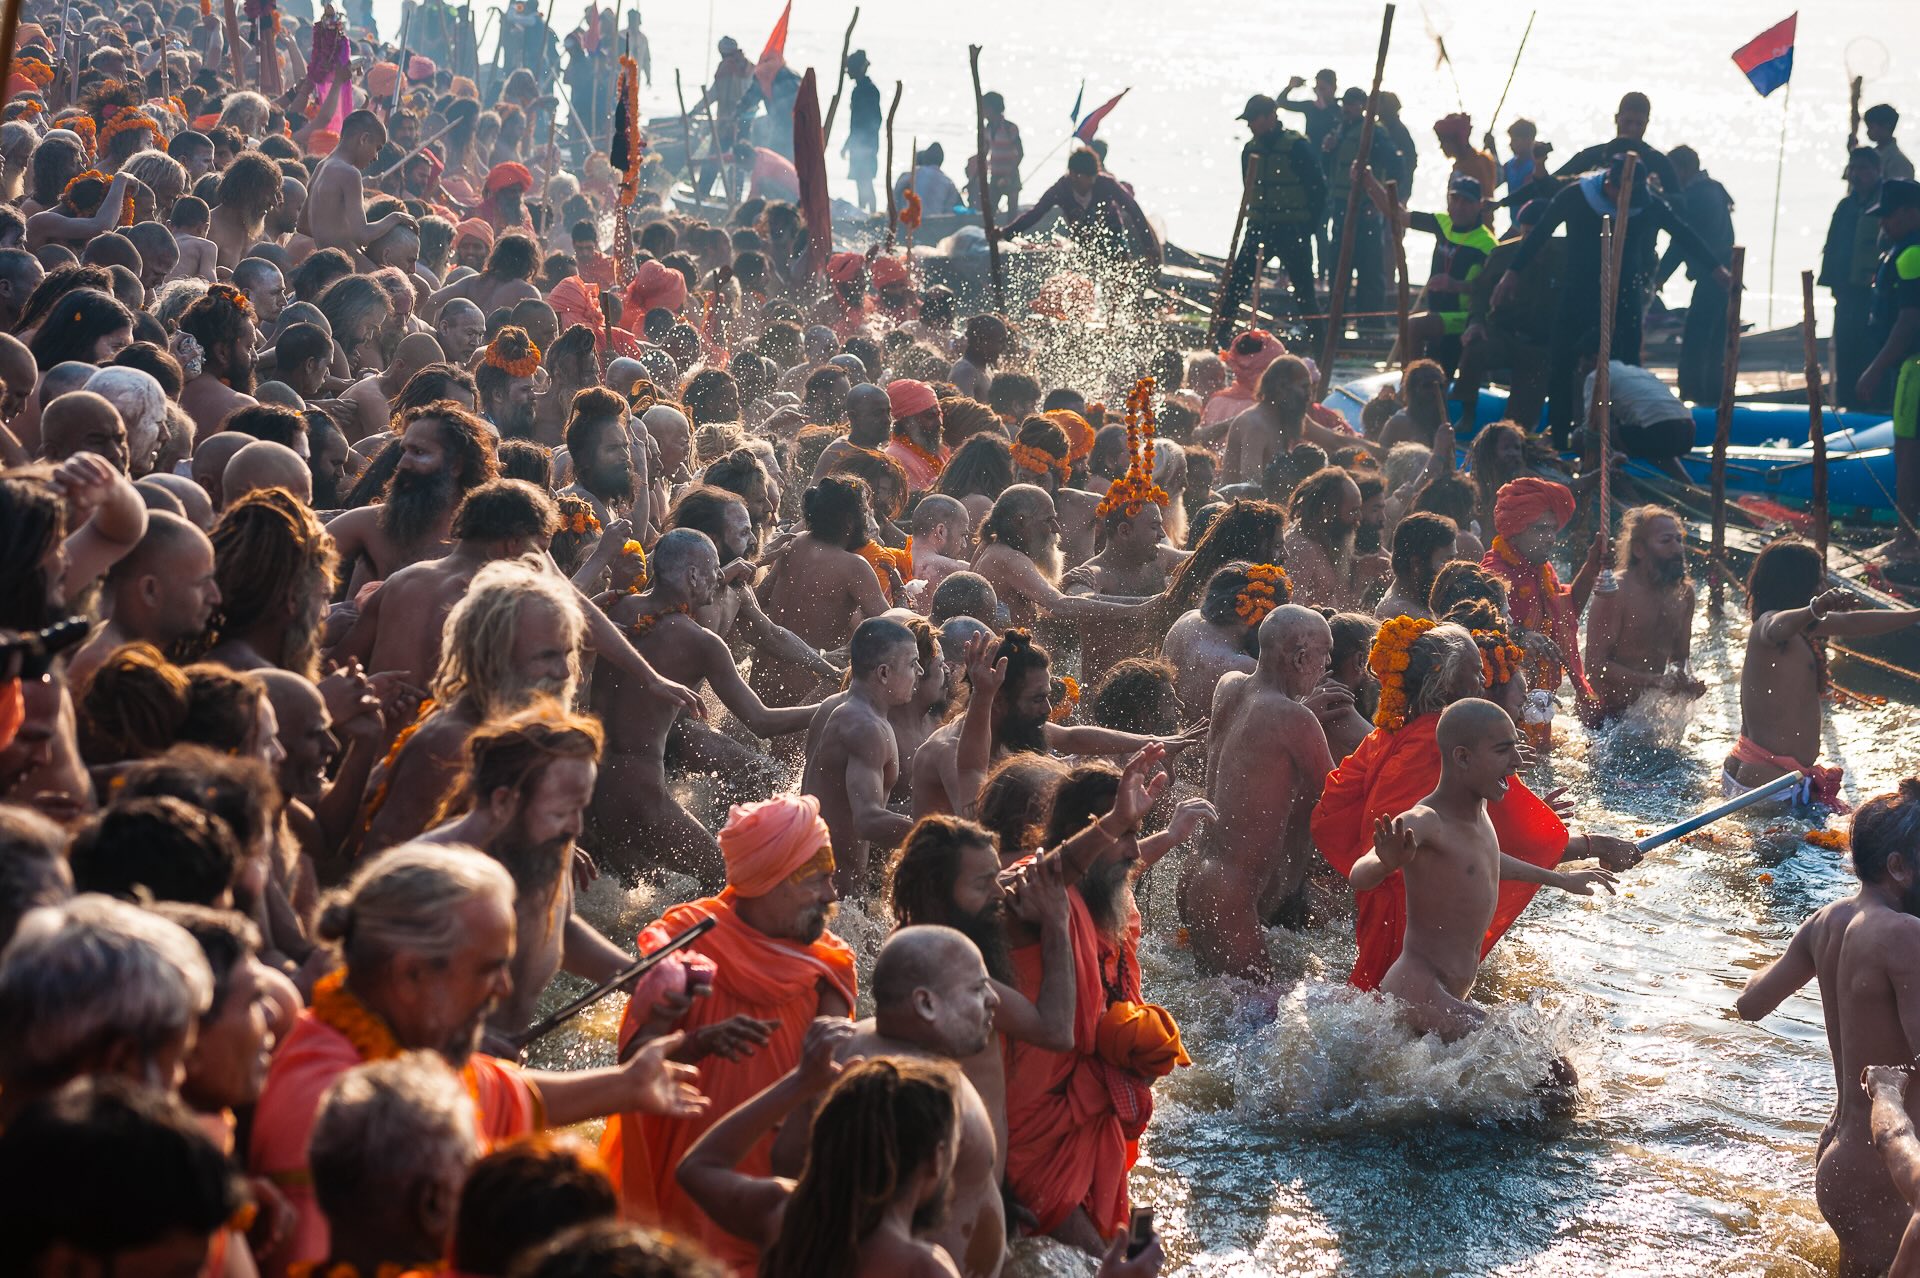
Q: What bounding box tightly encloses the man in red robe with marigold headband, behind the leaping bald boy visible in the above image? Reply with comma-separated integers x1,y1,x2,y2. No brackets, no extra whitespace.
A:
1311,616,1642,990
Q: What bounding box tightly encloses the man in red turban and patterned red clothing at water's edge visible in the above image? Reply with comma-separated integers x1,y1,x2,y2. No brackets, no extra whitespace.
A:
1480,476,1605,718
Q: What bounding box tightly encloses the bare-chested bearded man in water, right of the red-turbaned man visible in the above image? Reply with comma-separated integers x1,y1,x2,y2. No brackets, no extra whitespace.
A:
1586,507,1707,716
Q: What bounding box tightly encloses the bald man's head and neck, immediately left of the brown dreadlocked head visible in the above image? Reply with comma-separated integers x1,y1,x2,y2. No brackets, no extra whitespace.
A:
67,510,221,687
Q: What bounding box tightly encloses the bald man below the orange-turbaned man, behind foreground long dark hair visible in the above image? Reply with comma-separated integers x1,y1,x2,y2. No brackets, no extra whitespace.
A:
774,927,1006,1278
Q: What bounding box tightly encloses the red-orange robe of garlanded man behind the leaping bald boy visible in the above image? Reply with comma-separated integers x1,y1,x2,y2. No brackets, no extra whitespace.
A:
1313,714,1567,990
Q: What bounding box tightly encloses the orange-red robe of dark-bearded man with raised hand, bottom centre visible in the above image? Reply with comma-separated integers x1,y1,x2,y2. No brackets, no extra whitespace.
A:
1000,875,1154,1238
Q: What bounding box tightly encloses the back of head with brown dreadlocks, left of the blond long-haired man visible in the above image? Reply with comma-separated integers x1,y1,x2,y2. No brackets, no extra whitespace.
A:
207,487,338,679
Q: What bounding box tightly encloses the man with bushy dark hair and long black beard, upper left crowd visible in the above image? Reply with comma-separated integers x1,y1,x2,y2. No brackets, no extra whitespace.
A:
328,399,499,597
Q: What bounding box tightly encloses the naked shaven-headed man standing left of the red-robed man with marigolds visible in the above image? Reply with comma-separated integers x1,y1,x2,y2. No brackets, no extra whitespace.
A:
1179,604,1332,977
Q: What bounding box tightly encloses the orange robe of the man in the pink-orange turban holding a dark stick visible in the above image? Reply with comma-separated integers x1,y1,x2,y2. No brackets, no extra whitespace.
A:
601,888,856,1274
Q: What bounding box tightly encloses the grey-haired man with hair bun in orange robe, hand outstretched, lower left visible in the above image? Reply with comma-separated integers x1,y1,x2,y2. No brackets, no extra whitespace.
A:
248,842,697,1272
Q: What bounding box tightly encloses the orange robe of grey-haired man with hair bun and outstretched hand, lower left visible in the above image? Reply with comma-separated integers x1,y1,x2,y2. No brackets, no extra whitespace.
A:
248,1011,545,1272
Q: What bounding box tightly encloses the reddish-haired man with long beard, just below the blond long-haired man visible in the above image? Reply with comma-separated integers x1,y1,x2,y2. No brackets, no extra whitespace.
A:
420,700,632,1052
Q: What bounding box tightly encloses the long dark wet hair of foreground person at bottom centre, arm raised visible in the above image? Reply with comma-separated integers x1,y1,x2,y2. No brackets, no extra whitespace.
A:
760,1057,960,1278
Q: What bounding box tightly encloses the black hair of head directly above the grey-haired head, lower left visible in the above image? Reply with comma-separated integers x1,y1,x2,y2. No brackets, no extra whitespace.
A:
67,796,240,906
